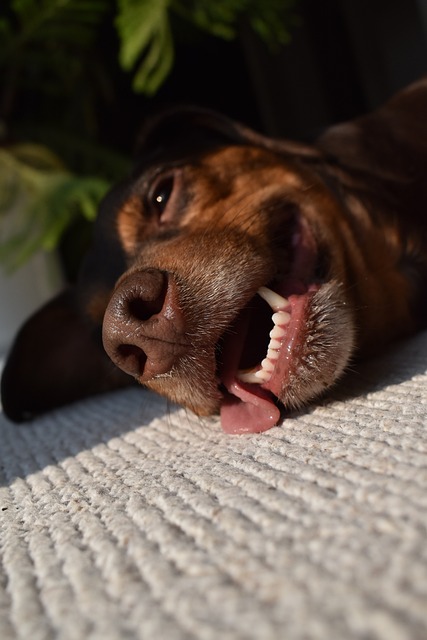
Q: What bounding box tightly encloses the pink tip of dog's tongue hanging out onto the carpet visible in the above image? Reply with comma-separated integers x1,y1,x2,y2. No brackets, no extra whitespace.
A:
221,379,280,433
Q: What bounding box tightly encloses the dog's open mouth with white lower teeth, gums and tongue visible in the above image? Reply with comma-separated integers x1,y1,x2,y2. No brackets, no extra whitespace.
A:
219,219,320,434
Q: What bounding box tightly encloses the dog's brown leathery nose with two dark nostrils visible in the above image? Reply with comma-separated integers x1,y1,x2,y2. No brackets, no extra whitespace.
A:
102,270,186,383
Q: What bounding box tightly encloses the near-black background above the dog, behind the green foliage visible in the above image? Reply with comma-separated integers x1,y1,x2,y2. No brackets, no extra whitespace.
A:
5,0,427,160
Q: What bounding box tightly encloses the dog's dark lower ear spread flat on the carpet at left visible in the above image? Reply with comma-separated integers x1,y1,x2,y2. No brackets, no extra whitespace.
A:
1,290,132,422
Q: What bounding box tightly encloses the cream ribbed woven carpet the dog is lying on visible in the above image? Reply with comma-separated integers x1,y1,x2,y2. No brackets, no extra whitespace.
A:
0,334,427,640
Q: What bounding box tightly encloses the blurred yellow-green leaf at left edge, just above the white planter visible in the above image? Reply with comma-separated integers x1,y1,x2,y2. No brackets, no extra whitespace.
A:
0,145,109,271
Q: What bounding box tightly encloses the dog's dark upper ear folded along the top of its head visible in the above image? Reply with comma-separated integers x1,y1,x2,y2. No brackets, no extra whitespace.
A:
137,107,317,160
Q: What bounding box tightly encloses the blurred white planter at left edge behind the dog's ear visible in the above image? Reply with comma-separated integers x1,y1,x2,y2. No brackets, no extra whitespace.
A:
0,253,63,353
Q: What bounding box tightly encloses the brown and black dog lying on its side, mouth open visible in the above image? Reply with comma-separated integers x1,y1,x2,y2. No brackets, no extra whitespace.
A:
1,79,427,433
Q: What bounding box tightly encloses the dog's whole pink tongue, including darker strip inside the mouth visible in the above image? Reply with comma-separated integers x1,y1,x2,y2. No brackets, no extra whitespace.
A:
221,310,280,433
